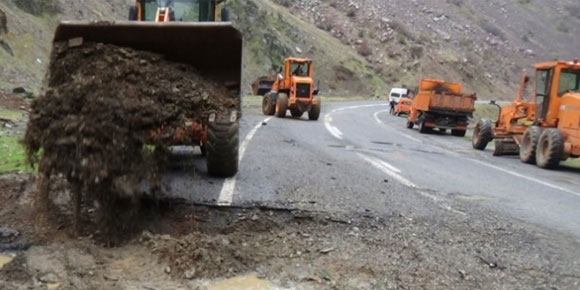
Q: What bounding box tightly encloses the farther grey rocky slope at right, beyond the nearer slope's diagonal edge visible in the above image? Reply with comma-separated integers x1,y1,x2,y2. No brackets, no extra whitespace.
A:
275,0,580,99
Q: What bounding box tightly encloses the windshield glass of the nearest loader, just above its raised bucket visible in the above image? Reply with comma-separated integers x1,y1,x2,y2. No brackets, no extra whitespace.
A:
143,0,215,22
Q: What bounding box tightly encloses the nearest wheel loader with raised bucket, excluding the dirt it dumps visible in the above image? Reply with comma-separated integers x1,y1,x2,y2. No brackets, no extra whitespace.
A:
48,0,242,177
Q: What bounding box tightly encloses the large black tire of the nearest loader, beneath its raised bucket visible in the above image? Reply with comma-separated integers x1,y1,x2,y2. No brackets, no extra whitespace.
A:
205,121,239,177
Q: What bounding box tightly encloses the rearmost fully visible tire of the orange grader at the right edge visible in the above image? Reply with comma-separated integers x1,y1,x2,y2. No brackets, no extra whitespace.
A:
536,128,564,169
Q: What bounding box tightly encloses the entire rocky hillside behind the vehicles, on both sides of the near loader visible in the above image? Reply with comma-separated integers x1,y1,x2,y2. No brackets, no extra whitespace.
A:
0,0,580,99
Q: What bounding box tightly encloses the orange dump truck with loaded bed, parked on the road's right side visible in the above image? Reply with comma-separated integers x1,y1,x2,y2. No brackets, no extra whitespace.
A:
407,79,477,137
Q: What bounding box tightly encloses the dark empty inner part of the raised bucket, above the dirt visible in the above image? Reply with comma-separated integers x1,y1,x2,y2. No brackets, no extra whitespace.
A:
54,21,242,95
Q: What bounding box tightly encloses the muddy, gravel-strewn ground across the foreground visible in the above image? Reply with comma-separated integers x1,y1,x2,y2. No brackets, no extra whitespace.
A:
0,170,580,289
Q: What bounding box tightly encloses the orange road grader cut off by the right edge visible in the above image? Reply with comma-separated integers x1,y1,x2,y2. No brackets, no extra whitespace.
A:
473,60,580,168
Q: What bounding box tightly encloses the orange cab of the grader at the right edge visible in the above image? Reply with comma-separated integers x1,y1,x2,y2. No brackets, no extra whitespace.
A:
535,61,580,127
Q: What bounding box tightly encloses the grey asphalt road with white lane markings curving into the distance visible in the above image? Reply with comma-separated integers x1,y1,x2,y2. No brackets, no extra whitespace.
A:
166,102,580,239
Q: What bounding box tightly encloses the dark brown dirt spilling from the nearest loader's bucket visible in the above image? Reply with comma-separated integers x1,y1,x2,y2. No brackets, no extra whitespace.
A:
25,43,239,238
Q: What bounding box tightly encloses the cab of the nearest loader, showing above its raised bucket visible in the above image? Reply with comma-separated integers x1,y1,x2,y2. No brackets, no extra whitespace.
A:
134,0,229,22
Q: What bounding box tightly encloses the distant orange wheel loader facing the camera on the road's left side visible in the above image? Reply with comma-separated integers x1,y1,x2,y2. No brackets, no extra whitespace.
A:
262,57,321,120
